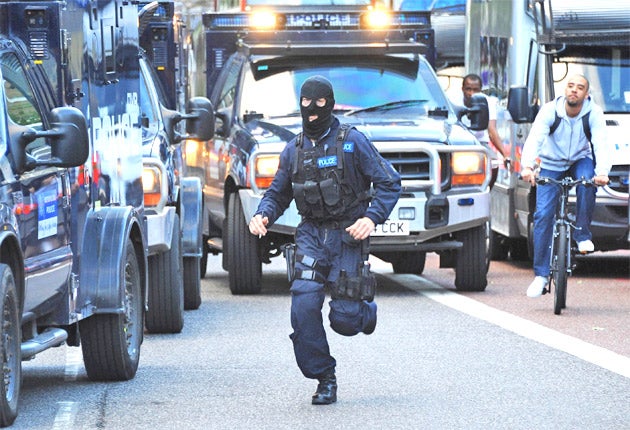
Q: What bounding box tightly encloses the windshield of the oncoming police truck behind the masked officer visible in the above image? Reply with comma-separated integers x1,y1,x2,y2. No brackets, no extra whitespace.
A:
240,58,447,118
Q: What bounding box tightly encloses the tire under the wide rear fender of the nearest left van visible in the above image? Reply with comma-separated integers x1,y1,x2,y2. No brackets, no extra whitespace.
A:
79,240,144,381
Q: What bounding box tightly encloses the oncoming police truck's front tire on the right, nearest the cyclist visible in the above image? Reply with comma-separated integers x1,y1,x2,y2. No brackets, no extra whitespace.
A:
455,225,490,291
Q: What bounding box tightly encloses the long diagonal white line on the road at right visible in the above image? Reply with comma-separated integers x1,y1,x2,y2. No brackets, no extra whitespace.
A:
387,274,630,378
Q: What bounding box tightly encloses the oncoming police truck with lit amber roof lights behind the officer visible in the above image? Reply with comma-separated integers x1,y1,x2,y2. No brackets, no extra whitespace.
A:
187,6,490,294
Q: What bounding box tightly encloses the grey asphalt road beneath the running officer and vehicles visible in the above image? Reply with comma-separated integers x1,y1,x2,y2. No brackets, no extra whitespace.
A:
13,254,630,430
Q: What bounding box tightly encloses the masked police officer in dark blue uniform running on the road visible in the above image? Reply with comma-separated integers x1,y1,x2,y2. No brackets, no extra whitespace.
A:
249,76,400,405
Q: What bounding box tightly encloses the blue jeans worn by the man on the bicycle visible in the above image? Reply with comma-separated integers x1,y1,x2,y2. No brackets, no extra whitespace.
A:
534,158,597,276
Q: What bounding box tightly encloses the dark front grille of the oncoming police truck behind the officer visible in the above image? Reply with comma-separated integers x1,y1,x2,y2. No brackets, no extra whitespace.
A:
381,151,450,189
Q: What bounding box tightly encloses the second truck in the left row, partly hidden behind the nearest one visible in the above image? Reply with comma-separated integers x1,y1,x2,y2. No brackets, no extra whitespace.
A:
138,1,212,322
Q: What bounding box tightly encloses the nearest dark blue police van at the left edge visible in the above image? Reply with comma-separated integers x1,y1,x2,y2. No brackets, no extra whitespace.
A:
0,1,147,426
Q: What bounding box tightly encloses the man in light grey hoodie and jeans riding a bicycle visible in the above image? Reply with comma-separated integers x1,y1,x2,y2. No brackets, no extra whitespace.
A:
521,75,613,297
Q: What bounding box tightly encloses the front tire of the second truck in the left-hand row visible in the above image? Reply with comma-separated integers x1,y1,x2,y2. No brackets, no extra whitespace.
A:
145,214,184,333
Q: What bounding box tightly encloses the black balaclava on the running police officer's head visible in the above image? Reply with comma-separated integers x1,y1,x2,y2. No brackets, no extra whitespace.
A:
300,76,335,139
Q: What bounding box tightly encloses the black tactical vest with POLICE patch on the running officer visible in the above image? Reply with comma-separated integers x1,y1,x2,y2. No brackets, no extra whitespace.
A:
293,124,367,221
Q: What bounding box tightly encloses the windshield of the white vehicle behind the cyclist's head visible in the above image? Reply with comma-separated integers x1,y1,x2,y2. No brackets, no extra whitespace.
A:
553,47,630,113
